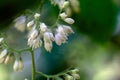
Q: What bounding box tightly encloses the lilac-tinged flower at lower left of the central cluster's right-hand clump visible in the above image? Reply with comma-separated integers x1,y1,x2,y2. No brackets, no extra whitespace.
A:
55,33,67,45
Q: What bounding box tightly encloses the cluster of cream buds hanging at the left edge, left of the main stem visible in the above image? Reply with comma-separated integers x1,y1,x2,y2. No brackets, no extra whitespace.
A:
0,37,24,71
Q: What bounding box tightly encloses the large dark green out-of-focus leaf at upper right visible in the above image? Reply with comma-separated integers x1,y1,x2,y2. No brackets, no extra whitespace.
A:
74,0,117,42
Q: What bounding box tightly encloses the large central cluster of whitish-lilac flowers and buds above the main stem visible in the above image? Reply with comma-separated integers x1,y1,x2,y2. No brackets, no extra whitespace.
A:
27,13,74,52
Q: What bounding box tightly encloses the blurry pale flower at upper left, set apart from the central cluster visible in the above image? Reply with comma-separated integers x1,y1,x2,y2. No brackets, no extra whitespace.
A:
14,16,26,32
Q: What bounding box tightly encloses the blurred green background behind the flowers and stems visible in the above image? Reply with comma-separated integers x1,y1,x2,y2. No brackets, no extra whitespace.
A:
0,0,120,80
